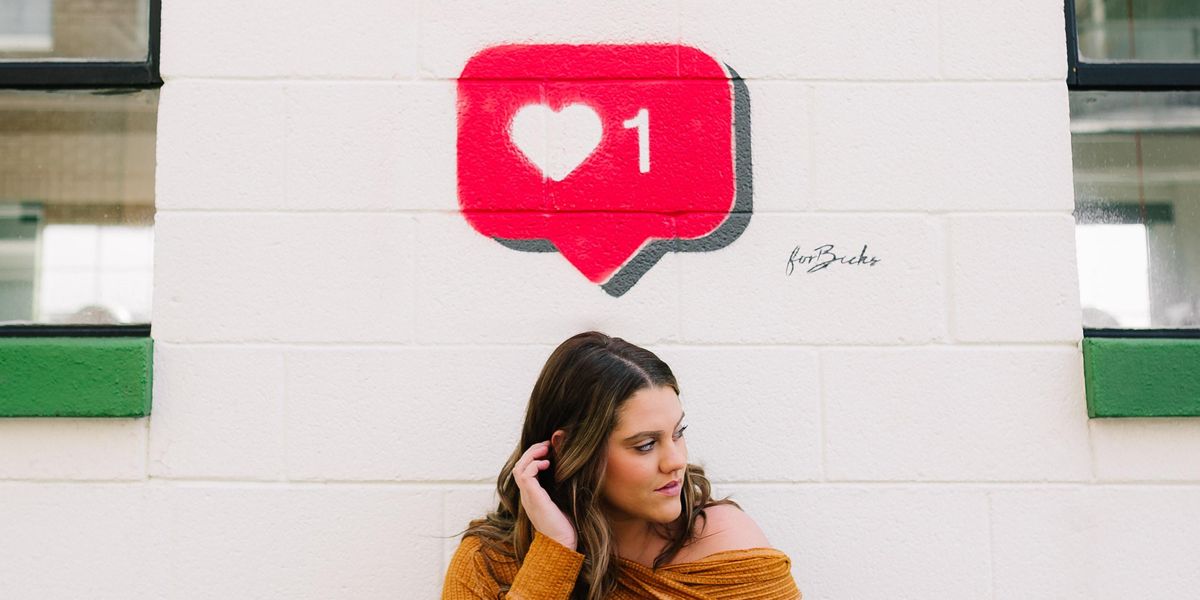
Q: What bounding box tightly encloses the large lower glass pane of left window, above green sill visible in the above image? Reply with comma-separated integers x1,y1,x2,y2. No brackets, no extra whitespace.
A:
0,90,158,324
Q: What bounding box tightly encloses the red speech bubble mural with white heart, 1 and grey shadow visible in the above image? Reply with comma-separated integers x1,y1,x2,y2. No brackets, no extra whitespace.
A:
458,44,751,295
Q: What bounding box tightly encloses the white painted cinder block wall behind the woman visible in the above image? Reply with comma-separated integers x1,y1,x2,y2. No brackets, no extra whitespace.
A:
0,0,1200,600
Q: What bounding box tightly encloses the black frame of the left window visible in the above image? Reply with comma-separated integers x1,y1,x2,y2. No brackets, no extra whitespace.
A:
0,0,162,337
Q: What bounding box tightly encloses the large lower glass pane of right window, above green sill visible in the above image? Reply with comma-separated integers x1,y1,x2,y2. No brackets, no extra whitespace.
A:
1070,91,1200,328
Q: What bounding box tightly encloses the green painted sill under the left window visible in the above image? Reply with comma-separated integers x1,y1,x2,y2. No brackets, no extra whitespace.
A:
0,337,154,416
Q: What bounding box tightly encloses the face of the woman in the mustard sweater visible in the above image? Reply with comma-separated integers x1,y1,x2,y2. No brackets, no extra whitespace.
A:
600,385,688,523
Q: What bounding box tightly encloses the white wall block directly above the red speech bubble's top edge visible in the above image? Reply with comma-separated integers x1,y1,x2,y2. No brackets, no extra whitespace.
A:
420,0,686,78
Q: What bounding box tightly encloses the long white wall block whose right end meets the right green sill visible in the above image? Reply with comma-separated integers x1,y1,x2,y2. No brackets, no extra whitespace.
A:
821,347,1091,481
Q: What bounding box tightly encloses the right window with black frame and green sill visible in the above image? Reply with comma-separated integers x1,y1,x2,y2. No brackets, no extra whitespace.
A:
1067,0,1200,416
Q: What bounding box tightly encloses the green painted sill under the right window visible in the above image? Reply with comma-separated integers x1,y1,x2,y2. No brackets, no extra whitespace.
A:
1084,337,1200,416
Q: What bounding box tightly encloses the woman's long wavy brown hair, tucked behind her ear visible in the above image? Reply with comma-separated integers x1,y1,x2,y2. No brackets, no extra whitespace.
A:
463,331,733,600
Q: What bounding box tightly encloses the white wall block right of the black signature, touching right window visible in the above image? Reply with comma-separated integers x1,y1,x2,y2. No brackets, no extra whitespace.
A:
949,215,1082,342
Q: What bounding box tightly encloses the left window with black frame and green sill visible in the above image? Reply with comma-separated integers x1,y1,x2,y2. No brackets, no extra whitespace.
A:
0,0,162,416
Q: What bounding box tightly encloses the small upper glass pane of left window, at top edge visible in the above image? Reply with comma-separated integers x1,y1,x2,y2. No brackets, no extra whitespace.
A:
0,0,150,61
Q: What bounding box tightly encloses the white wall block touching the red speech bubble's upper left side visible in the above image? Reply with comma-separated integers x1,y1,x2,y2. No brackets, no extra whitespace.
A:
284,82,458,210
